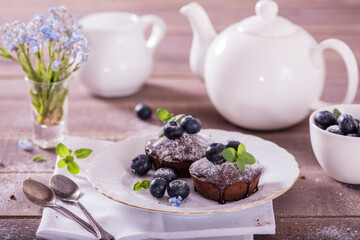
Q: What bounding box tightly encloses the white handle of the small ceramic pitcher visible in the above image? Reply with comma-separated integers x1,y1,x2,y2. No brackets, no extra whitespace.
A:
139,15,166,51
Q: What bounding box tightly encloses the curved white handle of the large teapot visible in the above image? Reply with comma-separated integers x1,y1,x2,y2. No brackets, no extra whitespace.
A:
312,39,359,109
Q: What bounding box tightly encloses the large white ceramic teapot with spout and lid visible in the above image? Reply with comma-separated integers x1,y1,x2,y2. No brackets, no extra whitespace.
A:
180,0,358,130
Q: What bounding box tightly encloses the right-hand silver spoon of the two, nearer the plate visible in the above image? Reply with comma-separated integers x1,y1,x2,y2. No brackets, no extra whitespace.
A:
50,174,115,239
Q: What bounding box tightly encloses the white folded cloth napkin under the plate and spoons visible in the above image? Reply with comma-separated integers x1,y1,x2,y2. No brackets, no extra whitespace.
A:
36,136,275,240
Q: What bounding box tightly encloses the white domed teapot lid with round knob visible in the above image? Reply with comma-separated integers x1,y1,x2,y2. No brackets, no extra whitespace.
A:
239,0,296,37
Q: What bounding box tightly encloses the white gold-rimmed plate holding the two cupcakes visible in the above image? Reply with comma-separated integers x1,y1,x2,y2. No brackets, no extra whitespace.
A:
88,129,300,214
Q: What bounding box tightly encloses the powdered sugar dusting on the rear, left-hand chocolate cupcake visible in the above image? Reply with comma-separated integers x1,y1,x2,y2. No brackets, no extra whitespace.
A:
146,133,211,162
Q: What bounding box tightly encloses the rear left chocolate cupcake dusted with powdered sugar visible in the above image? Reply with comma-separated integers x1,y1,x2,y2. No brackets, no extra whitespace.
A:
145,133,211,177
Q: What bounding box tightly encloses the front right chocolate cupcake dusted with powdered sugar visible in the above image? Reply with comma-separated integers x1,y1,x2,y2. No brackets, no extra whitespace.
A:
189,158,263,204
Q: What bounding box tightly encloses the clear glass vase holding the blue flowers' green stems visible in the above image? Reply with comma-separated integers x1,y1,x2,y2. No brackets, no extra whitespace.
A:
25,76,69,149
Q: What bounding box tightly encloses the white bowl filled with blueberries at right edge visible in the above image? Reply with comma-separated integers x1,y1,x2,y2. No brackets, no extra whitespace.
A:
309,104,360,184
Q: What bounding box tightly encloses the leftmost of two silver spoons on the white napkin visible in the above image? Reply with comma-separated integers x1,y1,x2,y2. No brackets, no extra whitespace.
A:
22,179,97,236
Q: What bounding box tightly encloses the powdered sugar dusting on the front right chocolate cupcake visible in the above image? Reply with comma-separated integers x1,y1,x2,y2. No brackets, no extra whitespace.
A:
190,158,263,189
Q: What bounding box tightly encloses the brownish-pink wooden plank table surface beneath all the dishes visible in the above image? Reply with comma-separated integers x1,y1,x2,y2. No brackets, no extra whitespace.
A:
0,0,360,239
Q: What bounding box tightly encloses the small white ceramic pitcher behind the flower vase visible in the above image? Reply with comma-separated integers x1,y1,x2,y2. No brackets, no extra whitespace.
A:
79,12,165,97
